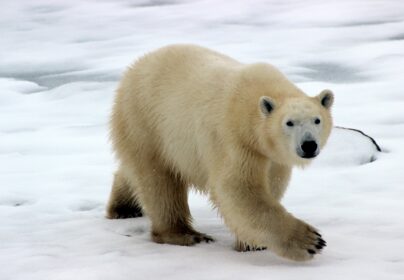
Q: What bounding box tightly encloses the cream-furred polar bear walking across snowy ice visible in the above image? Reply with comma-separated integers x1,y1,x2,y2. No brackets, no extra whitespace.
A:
107,45,333,261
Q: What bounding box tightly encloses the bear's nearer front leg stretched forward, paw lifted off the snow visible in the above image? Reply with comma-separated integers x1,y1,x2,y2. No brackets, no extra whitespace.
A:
211,164,326,261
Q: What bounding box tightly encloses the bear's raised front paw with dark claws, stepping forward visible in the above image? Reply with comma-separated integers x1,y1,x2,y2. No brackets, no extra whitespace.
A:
281,219,327,261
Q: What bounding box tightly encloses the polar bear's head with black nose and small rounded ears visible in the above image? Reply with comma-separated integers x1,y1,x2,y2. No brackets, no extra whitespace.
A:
259,90,334,166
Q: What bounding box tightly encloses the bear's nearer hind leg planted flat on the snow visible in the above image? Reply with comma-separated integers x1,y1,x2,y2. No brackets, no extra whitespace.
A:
133,161,213,246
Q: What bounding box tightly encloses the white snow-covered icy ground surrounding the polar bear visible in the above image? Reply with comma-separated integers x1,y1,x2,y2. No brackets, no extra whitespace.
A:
0,0,404,280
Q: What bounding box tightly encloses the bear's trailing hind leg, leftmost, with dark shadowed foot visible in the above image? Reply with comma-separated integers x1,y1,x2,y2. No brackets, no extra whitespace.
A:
107,171,143,219
